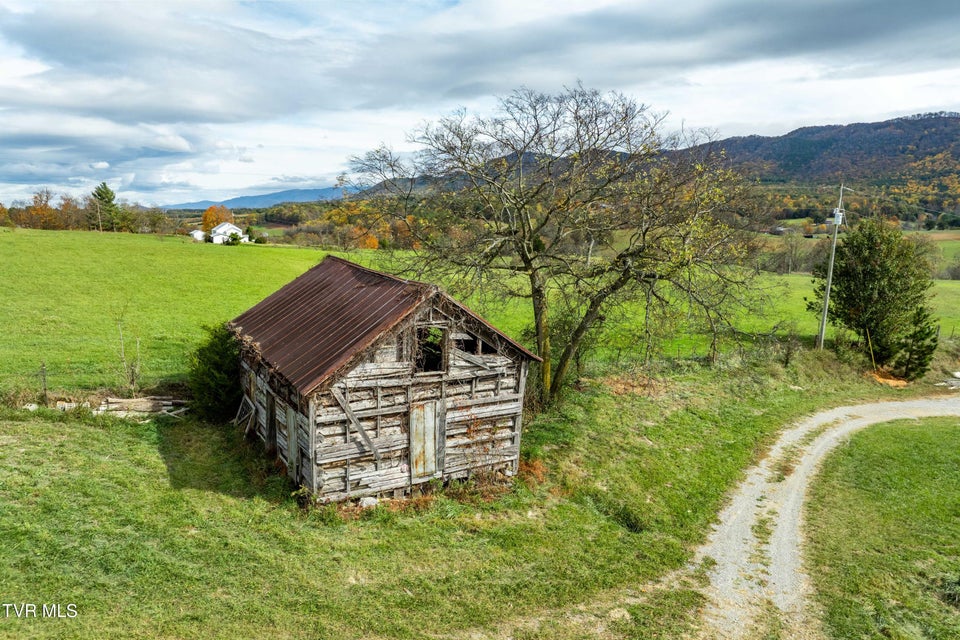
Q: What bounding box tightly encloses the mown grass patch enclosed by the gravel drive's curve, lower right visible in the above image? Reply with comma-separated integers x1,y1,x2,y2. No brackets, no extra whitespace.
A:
807,419,960,640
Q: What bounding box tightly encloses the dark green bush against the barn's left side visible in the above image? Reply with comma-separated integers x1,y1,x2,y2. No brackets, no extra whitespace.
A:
189,325,241,422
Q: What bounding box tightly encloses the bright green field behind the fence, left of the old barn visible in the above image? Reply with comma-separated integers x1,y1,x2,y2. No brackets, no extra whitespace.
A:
0,229,322,388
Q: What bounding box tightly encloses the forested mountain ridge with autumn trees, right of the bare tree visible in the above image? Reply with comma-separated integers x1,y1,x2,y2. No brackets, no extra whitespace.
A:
716,112,960,224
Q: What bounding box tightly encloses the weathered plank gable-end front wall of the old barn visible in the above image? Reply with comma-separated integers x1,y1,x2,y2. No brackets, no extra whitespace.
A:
313,309,527,501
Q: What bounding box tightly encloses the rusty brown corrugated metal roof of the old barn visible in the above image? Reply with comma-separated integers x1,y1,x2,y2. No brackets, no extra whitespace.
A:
230,256,539,395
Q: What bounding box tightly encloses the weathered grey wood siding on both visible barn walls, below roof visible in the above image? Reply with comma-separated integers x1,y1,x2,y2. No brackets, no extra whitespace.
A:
241,298,528,502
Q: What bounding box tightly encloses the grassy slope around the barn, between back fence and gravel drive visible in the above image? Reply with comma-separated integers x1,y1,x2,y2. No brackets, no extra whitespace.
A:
0,353,936,639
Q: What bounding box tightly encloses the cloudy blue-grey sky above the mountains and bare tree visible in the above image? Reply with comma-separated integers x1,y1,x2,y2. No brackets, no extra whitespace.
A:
0,0,960,205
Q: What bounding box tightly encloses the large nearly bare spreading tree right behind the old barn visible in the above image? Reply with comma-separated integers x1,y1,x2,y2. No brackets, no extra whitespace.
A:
352,86,753,402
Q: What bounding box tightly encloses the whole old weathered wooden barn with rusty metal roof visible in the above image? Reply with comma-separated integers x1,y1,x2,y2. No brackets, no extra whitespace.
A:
230,256,538,502
